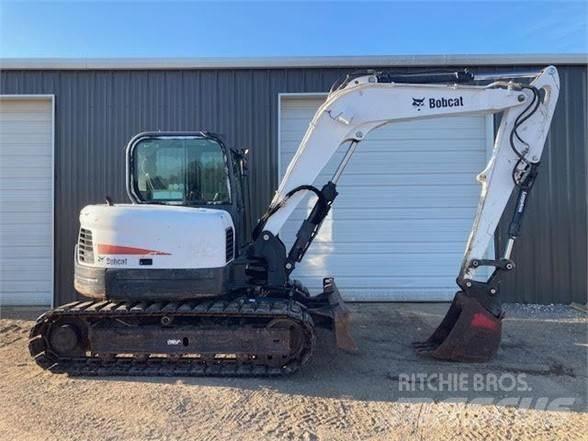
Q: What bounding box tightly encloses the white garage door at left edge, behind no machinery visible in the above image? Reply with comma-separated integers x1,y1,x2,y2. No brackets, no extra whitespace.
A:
0,97,53,305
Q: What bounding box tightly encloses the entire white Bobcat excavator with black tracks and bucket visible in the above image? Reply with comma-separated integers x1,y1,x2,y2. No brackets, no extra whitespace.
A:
29,66,559,376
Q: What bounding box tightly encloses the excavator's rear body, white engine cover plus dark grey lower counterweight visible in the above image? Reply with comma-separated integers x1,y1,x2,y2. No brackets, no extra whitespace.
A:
75,204,235,300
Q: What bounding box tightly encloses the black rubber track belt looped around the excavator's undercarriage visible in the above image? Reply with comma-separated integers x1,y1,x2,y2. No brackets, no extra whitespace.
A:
29,298,316,377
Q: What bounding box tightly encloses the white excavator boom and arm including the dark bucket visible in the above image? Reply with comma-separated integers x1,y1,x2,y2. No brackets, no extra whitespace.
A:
254,66,559,361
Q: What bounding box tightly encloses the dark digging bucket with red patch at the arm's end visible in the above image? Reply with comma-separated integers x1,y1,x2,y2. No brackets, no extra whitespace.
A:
413,291,502,362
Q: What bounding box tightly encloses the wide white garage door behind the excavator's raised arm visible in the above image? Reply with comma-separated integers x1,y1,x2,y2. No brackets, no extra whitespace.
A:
279,96,492,301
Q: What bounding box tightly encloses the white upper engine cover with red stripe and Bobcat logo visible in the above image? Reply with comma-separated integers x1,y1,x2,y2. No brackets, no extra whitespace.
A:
77,204,235,269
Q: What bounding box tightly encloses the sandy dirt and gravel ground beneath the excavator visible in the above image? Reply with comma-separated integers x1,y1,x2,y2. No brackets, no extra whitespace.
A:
0,304,588,441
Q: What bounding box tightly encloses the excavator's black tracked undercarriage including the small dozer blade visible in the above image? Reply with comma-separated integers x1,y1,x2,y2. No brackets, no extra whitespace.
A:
29,279,355,376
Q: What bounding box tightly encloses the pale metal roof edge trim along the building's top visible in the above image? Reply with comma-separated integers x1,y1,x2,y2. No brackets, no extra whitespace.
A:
0,54,588,70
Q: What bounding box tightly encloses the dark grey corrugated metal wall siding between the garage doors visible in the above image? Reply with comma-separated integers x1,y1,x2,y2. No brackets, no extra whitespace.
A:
0,66,588,304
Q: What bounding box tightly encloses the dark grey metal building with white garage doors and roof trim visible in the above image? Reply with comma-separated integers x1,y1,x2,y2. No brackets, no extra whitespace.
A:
0,55,588,305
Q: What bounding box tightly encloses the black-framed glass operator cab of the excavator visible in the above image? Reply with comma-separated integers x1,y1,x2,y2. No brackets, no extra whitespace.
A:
126,131,250,244
